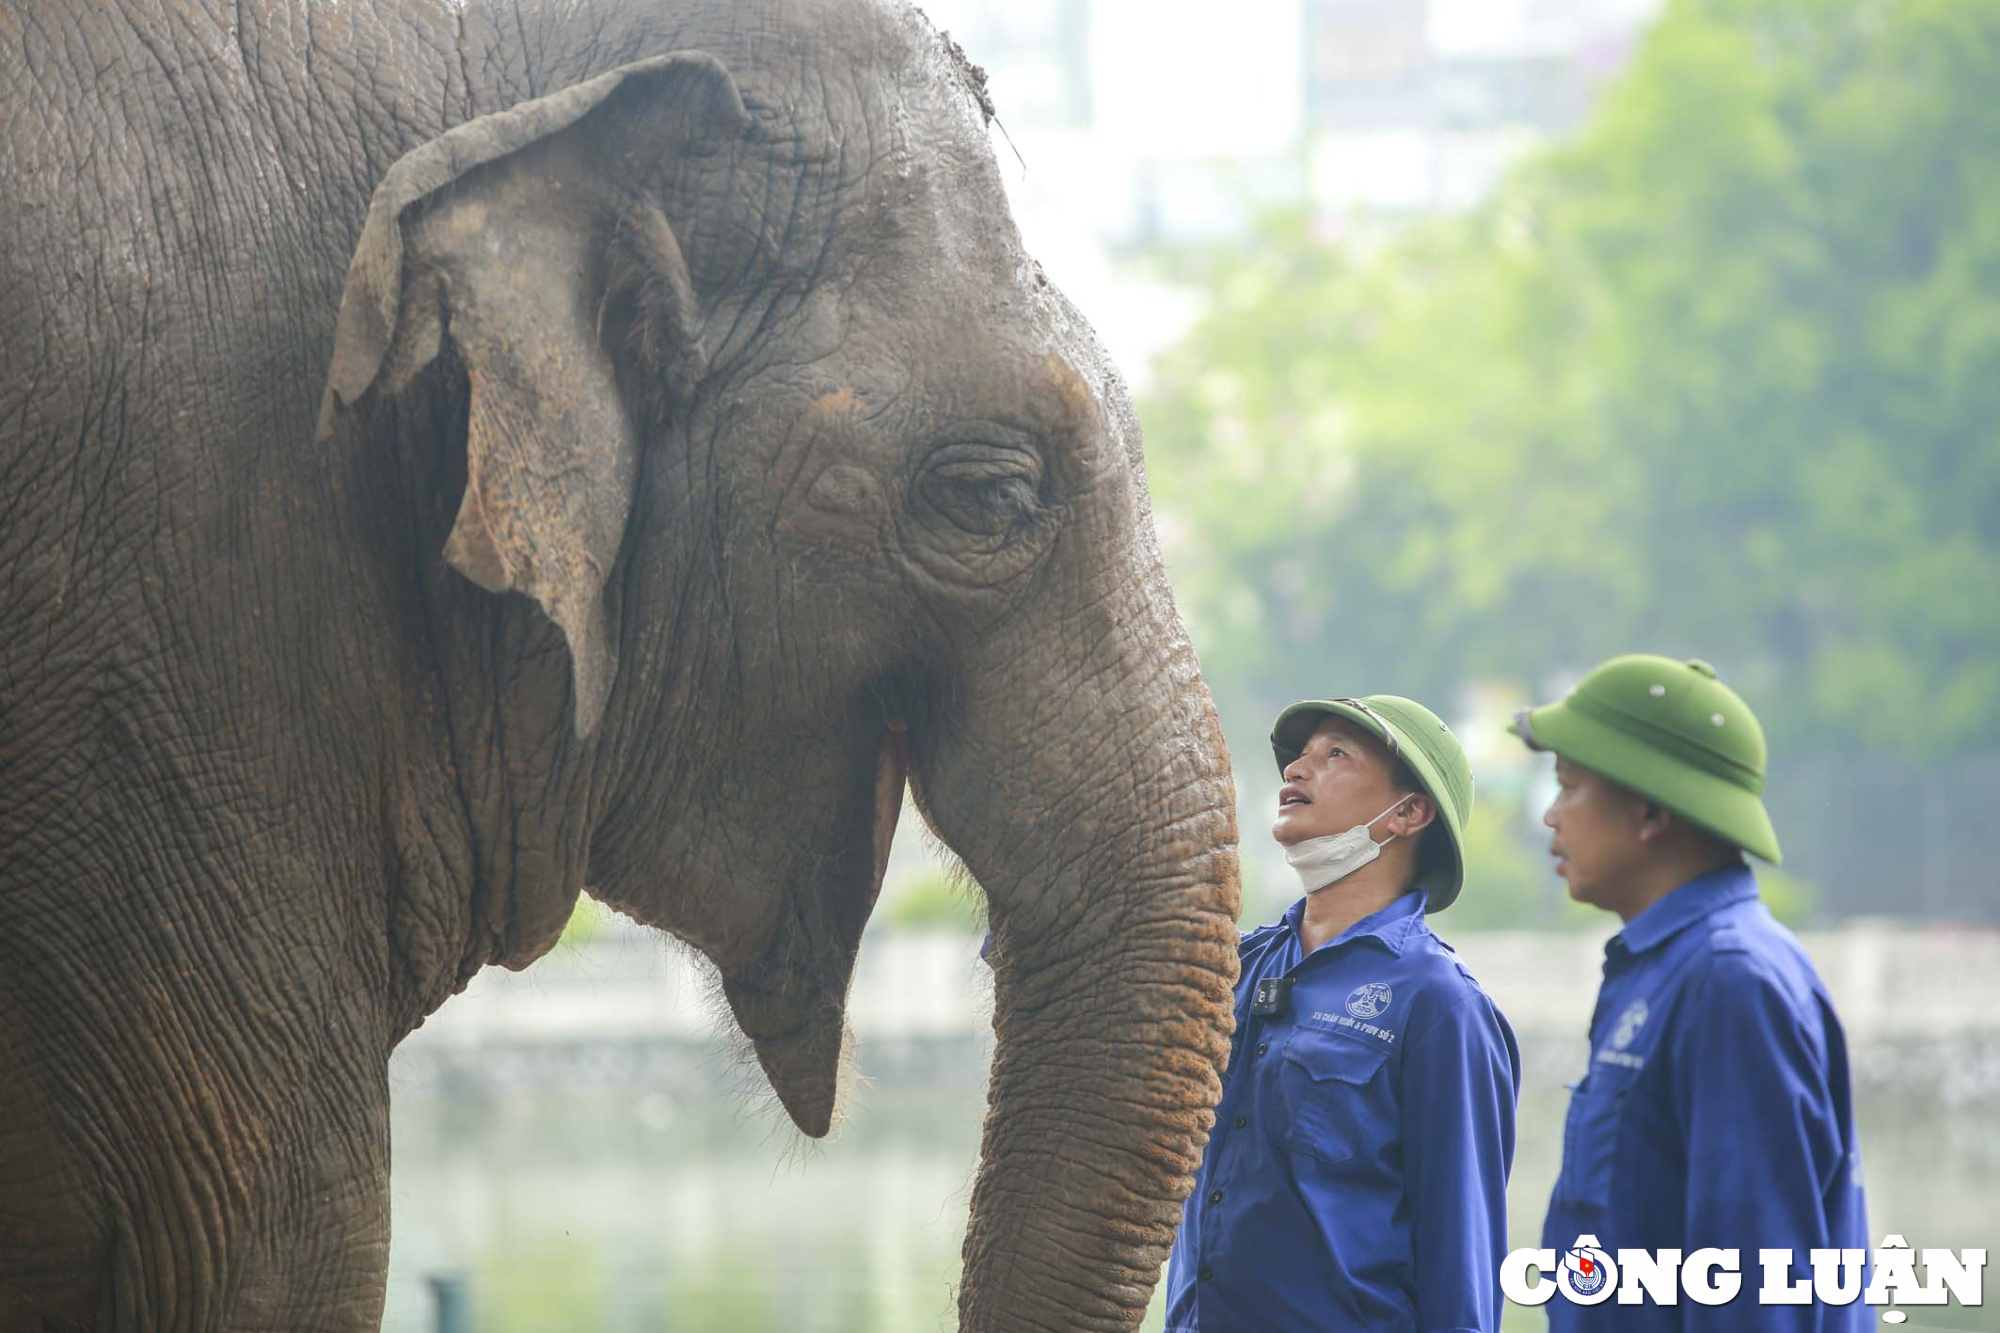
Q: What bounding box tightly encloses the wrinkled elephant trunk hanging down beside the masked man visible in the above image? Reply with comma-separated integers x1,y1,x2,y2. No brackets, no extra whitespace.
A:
924,598,1238,1333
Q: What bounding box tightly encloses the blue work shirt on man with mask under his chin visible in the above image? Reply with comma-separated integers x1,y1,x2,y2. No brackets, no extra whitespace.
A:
1166,880,1520,1333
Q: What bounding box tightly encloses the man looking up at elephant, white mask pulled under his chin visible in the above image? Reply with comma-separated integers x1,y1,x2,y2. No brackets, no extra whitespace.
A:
1166,695,1520,1333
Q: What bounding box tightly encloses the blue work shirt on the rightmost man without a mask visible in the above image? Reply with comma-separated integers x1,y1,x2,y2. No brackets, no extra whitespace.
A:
1542,865,1876,1333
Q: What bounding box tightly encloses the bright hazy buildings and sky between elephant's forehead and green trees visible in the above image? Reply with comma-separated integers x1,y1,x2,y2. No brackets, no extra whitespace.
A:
922,0,1660,380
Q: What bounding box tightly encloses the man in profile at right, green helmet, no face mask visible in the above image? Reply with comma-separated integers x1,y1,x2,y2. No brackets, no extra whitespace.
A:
1514,654,1874,1333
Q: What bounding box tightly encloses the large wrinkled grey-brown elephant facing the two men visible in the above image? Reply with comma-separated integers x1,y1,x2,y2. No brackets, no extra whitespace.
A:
0,0,1236,1329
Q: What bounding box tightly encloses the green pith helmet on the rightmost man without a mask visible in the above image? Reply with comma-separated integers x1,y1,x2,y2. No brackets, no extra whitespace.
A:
1514,652,1782,865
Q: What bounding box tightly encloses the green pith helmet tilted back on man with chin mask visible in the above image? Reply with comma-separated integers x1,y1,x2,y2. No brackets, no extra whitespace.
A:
1270,695,1472,913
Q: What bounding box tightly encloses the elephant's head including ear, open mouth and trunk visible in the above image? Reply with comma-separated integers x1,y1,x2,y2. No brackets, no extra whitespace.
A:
320,4,1236,1329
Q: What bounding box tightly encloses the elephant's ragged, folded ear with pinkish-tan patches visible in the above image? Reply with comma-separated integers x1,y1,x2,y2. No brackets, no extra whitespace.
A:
318,52,750,737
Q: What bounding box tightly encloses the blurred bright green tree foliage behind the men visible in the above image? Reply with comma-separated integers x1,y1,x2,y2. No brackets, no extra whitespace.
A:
1142,0,2000,764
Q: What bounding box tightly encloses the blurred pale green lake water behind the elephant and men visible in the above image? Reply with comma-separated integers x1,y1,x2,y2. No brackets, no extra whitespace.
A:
384,1039,2000,1333
